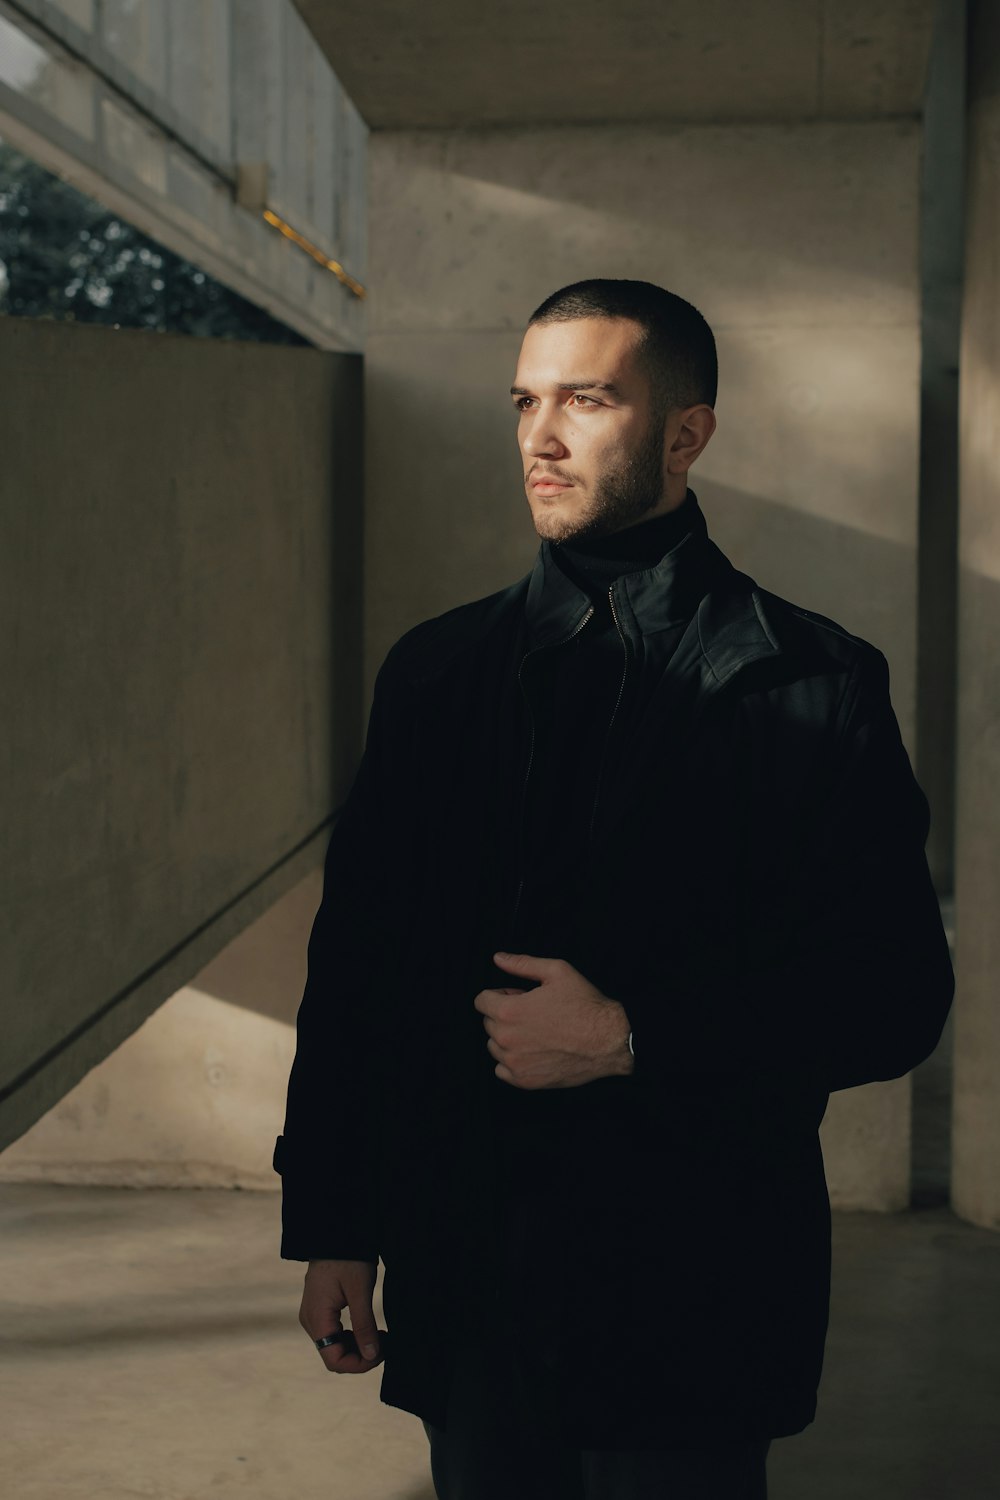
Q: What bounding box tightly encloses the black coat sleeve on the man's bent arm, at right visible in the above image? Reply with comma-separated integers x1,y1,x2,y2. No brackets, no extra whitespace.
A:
615,648,955,1092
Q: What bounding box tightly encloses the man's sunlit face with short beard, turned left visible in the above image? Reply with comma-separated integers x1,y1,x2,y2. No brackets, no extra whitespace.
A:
511,318,671,542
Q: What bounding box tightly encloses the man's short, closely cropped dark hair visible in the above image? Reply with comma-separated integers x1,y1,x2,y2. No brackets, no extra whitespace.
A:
528,276,718,416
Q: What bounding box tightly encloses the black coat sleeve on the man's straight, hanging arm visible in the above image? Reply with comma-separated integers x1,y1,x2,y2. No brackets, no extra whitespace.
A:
273,659,401,1262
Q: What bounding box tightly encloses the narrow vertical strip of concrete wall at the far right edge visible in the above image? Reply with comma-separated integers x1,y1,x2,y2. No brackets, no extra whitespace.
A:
952,3,1000,1229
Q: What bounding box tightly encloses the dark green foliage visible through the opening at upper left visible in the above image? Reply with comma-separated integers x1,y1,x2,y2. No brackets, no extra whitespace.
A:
0,141,309,345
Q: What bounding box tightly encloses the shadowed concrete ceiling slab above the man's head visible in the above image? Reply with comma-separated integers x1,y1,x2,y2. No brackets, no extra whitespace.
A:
295,0,936,131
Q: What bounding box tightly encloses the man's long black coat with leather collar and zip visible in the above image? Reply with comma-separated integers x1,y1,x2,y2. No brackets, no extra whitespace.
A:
274,492,955,1448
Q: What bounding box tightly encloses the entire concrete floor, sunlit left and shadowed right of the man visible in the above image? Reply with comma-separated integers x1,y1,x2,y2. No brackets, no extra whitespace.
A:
0,1184,1000,1500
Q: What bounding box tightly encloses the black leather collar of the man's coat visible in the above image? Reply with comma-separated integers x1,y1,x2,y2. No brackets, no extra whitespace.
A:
525,489,781,686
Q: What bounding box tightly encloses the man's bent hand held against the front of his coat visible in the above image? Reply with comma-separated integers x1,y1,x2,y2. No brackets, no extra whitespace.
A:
472,953,634,1089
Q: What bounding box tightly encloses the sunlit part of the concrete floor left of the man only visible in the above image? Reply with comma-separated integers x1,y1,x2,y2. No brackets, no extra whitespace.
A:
0,1184,433,1500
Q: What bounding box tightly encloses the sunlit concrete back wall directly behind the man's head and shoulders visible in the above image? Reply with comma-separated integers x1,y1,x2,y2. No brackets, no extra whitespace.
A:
366,122,921,1209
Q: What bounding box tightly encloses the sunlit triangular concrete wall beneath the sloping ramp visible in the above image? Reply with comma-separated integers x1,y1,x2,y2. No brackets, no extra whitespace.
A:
0,870,322,1191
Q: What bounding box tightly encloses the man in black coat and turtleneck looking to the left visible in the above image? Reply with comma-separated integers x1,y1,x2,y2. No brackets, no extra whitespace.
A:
274,281,954,1500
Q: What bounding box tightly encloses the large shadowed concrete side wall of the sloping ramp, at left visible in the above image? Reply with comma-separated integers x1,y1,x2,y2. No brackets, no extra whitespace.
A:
0,318,363,1146
